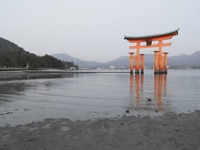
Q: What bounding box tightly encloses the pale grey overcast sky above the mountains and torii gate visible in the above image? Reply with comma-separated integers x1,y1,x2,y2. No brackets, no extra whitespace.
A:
0,0,200,62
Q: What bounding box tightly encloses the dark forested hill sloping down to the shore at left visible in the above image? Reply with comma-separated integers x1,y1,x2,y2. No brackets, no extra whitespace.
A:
0,37,78,69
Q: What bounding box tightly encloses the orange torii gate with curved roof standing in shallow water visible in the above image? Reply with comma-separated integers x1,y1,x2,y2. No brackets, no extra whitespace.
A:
124,29,179,74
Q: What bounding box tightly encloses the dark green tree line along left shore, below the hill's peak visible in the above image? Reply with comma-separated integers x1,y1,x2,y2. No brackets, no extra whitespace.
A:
0,49,78,69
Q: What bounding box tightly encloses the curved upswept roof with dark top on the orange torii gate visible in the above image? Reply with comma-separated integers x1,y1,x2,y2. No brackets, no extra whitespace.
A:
124,29,179,42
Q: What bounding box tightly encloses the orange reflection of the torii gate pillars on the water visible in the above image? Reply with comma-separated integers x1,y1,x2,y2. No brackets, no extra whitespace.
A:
128,74,169,111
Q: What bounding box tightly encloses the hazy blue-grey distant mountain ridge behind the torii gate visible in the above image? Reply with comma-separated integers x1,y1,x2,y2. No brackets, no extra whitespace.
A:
52,51,200,69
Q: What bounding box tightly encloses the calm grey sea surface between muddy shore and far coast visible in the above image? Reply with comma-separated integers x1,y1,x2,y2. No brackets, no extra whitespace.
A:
0,70,200,126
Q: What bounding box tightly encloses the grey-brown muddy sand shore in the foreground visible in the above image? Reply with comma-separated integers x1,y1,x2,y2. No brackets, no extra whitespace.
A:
0,111,200,150
